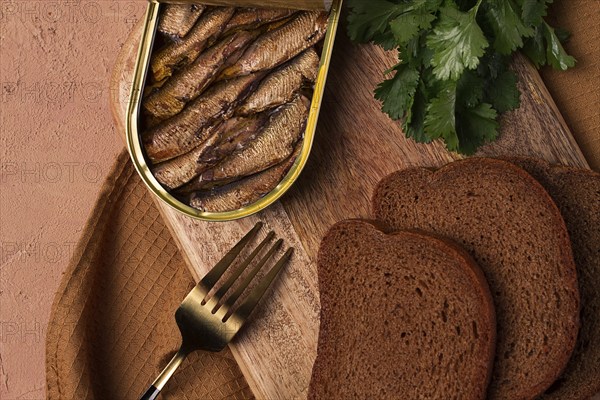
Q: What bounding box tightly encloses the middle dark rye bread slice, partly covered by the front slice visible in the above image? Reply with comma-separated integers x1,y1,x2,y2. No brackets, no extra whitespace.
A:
373,158,579,400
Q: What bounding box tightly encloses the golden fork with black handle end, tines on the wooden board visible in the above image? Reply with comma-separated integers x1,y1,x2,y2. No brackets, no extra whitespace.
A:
140,222,294,400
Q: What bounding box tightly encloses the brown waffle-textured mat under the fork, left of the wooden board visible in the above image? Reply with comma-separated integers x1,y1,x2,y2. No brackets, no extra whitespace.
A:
46,152,253,400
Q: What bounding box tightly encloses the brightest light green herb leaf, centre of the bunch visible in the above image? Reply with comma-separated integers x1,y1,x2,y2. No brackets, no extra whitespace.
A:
427,3,488,80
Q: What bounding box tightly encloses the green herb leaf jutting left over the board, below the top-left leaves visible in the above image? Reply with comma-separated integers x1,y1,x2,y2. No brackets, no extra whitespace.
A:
375,64,419,119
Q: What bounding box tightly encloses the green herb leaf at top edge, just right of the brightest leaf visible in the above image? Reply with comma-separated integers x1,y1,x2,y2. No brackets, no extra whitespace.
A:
486,0,535,54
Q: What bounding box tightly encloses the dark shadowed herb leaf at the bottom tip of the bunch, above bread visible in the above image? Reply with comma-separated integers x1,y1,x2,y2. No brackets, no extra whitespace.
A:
458,103,499,154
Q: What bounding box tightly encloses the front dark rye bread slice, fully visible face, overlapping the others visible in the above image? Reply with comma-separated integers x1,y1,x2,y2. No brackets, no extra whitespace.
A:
308,220,495,400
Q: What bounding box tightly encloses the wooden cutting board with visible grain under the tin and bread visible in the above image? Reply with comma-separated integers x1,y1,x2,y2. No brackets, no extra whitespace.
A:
111,17,588,400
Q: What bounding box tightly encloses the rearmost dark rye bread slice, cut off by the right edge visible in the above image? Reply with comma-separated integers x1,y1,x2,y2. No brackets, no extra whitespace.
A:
509,158,600,400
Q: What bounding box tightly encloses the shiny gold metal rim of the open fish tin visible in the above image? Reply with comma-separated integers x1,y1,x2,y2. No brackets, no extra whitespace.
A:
126,0,342,221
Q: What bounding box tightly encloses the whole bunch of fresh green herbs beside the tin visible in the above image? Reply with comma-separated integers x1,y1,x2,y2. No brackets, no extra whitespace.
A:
348,0,575,154
